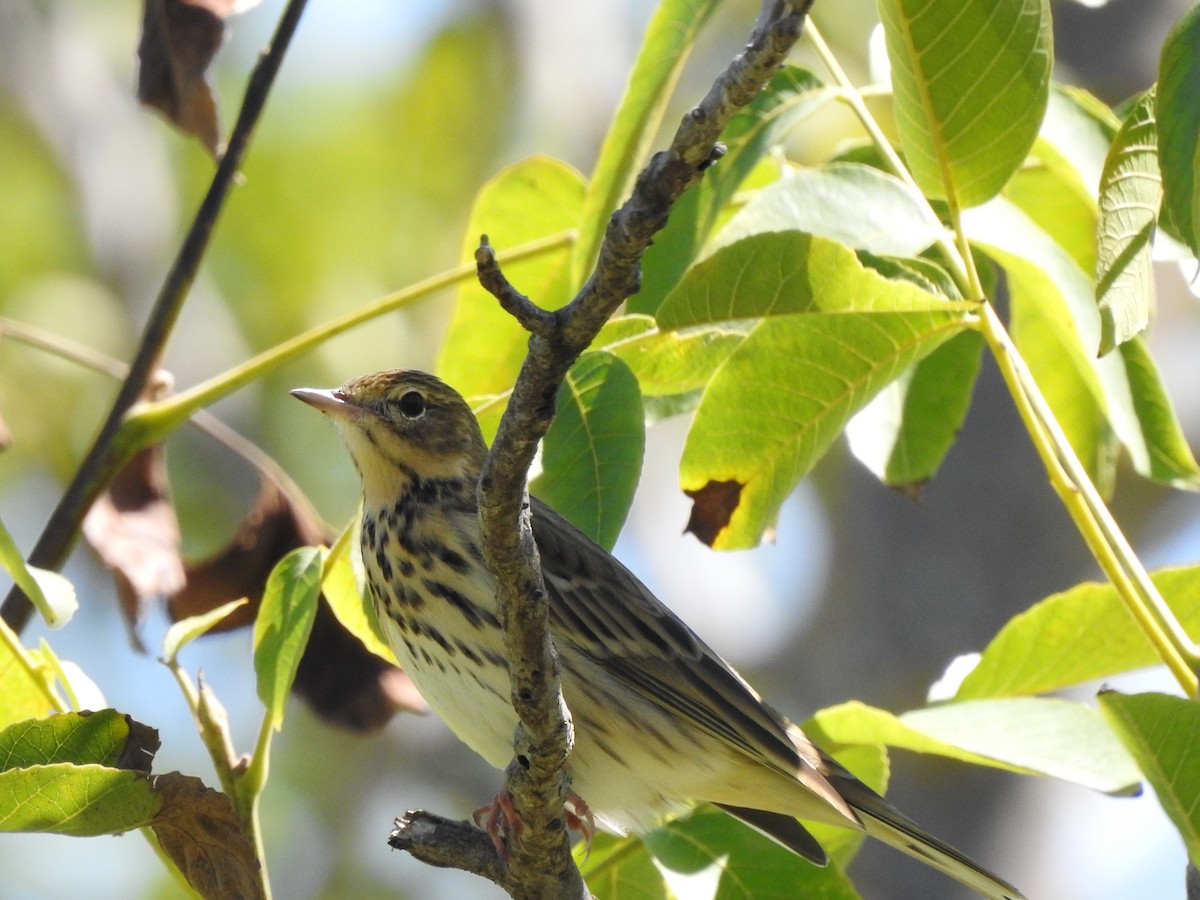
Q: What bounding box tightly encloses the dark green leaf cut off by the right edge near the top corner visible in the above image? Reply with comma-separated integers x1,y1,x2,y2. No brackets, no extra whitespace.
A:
1154,6,1200,254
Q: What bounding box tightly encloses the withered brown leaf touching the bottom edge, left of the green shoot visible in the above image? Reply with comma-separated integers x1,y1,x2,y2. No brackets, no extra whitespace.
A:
150,772,265,900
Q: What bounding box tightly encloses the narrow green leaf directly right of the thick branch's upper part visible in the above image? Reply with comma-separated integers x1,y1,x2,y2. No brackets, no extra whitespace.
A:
629,66,835,313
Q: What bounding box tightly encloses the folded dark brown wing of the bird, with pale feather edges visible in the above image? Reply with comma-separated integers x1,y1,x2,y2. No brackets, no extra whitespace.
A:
532,498,858,822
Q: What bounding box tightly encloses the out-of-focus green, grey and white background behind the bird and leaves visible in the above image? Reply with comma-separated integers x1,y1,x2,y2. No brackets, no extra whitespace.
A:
0,0,1200,900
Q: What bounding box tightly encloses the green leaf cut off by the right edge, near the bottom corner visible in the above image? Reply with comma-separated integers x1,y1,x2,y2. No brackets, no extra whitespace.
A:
1100,691,1200,865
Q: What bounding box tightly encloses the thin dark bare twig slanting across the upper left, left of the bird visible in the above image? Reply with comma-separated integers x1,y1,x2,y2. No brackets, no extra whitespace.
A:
0,0,307,634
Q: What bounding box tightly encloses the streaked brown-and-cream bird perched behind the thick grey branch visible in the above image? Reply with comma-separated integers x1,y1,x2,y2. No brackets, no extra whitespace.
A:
292,370,1022,900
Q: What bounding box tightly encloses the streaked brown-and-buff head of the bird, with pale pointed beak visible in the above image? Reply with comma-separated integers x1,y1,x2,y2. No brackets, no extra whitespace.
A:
292,368,487,505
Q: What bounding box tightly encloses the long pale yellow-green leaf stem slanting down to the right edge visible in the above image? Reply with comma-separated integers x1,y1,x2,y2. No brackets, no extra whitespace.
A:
804,22,1200,697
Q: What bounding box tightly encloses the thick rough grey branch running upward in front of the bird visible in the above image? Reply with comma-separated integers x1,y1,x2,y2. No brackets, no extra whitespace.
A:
463,0,812,898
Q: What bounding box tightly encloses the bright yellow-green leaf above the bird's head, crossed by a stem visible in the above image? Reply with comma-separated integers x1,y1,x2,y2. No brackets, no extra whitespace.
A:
437,156,583,396
